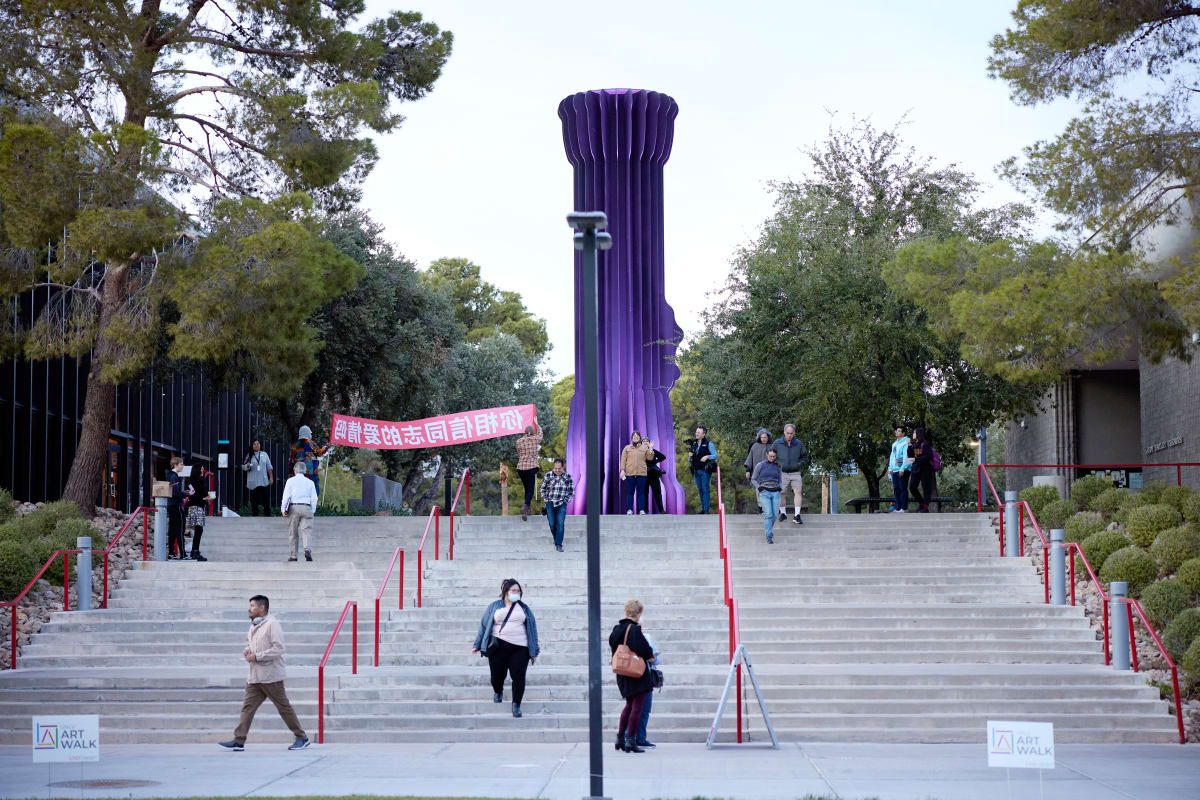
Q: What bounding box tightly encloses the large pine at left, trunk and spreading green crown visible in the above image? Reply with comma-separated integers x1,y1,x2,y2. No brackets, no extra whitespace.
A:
0,0,451,509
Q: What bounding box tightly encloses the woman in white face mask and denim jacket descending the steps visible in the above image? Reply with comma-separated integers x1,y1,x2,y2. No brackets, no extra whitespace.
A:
470,578,539,717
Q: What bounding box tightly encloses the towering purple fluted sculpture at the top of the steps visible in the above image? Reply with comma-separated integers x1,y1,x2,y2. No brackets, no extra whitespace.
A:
558,89,684,513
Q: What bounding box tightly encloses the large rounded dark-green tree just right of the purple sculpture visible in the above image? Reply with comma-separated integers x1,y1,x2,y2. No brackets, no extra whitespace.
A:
682,122,1038,495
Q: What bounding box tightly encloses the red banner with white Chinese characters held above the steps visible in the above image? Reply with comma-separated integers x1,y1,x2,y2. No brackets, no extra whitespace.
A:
329,404,536,450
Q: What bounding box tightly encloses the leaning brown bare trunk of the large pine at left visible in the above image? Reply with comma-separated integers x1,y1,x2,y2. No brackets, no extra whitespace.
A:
62,265,129,517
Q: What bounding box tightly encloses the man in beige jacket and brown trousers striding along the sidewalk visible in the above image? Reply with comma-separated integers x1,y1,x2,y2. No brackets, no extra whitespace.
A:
221,595,308,752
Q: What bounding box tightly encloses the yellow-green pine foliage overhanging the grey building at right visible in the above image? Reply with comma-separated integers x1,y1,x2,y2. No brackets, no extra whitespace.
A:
936,0,1200,380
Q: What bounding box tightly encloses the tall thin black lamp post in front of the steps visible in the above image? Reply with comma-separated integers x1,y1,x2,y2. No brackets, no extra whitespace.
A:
566,211,612,800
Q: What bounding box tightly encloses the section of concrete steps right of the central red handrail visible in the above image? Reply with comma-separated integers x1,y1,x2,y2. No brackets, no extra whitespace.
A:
727,513,1177,744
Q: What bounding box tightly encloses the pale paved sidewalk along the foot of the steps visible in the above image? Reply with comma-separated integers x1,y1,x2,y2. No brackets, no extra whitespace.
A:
0,734,1200,800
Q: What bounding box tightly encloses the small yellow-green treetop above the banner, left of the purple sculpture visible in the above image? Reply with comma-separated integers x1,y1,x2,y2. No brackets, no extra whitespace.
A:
421,258,551,361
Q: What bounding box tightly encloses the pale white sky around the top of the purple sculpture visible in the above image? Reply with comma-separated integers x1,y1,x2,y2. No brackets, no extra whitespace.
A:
364,0,1073,377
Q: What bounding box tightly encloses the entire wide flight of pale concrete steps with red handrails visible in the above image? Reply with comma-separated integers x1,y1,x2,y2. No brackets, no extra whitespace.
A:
0,515,1174,744
